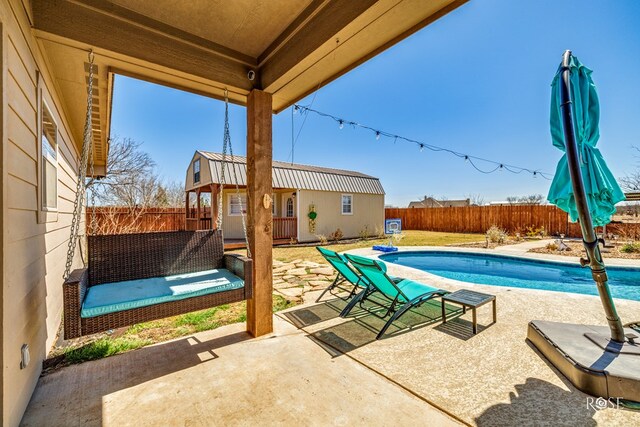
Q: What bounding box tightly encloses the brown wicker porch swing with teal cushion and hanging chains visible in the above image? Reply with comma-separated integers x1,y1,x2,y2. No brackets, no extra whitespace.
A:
63,52,253,339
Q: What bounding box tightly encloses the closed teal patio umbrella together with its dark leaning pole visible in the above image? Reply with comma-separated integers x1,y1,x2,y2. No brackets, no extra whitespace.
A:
548,51,625,342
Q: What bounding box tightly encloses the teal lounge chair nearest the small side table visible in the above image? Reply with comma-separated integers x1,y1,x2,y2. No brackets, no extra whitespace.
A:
340,254,449,339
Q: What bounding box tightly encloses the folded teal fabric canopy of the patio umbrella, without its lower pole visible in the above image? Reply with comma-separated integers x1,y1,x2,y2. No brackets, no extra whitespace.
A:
547,56,625,227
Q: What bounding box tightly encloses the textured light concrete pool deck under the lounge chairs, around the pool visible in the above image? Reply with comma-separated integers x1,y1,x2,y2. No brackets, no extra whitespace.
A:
278,245,640,426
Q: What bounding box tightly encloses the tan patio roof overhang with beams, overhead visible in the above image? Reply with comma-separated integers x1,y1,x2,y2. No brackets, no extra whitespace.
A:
26,0,467,174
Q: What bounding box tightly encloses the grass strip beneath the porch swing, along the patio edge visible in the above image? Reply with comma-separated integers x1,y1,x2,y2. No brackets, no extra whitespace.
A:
45,295,295,372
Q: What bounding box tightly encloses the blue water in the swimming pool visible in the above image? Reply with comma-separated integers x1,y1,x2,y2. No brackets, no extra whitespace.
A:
380,251,640,301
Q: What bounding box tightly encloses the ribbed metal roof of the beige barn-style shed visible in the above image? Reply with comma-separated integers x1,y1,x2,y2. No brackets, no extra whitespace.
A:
197,150,384,194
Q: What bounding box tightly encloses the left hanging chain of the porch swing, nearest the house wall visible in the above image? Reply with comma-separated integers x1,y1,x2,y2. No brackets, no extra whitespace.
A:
63,51,94,280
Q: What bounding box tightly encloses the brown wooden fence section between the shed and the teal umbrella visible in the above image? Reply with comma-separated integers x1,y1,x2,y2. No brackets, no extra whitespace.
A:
385,205,580,236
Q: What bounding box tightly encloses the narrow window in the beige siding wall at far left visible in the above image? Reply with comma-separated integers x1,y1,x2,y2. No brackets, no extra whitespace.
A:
41,102,58,210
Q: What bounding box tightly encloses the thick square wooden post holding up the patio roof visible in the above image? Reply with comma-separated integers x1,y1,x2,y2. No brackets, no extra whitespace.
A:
247,89,273,337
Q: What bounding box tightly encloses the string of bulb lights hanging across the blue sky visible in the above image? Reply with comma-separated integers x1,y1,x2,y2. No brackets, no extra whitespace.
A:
294,104,553,181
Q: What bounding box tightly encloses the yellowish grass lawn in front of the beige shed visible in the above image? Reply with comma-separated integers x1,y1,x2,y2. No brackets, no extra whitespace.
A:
237,230,484,262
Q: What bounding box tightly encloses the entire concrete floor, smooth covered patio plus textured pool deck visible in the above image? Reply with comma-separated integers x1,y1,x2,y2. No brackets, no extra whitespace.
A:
23,242,640,427
